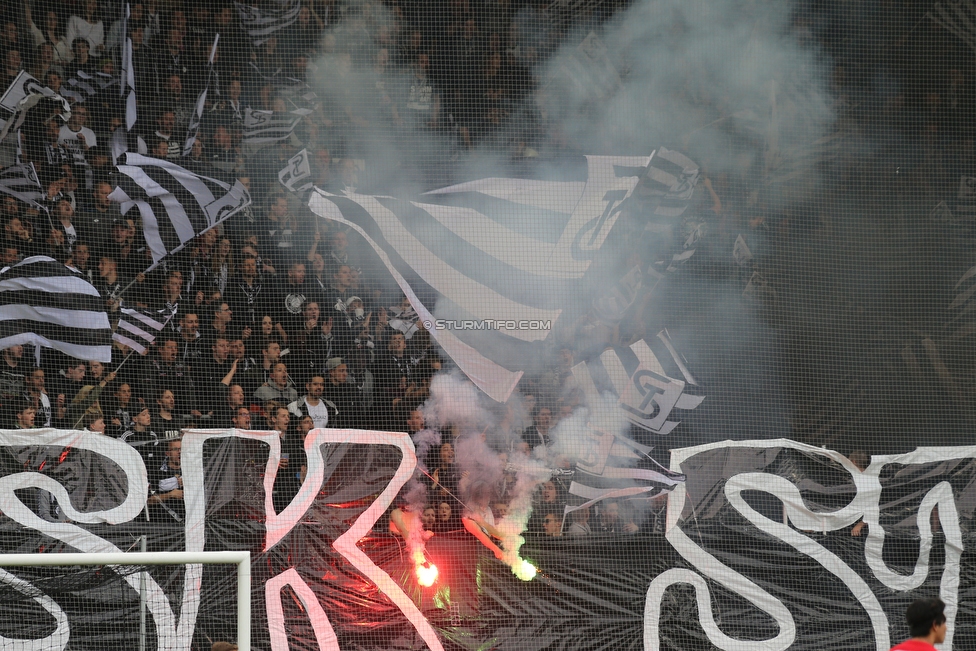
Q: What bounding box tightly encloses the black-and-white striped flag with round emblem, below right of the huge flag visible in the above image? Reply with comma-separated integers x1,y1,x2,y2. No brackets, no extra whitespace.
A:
572,330,705,434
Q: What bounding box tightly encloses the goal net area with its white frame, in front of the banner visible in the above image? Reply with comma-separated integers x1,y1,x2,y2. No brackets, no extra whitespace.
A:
0,552,251,651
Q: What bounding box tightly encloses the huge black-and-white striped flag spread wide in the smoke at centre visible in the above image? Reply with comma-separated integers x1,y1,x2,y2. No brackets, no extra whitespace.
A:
308,156,648,402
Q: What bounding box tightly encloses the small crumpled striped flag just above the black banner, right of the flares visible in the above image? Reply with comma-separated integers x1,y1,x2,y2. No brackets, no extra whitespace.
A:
565,428,685,514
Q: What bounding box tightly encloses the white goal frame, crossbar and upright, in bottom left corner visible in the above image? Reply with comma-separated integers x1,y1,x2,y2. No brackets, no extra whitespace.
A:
0,551,251,651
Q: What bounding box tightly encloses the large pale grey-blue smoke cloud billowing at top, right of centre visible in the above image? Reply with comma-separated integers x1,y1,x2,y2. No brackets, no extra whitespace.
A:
539,0,834,202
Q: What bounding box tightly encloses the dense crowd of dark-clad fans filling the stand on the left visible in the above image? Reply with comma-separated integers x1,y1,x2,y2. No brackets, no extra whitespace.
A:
0,0,656,532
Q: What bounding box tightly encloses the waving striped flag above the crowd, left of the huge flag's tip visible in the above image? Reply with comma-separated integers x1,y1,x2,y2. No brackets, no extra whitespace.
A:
109,152,251,271
